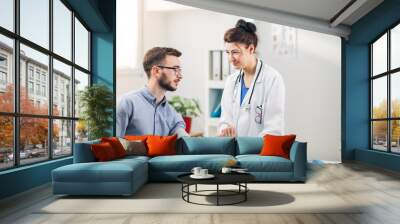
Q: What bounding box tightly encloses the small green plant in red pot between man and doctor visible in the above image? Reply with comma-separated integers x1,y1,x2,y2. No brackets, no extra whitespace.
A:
168,96,201,133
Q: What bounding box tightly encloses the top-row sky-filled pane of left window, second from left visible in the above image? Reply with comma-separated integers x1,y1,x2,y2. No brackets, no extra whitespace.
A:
20,0,49,48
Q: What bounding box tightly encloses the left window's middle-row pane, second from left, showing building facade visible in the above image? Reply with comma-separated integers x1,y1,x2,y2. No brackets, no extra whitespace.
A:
20,44,49,115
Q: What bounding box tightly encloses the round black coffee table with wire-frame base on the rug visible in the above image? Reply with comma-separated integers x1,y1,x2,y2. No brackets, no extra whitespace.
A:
177,173,255,206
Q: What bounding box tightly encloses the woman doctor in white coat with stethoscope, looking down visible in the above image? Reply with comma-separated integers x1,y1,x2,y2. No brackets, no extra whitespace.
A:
218,19,285,137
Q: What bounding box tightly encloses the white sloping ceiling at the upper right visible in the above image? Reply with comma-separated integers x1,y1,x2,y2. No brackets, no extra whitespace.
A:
168,0,383,37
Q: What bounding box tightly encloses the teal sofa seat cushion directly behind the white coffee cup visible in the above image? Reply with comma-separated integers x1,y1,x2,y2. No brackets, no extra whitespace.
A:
149,154,235,172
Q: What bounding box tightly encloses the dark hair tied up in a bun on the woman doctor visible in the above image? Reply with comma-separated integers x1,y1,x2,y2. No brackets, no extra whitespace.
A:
224,19,258,48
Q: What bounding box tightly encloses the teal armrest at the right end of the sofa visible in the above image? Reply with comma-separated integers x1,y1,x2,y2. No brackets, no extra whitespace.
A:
290,141,307,181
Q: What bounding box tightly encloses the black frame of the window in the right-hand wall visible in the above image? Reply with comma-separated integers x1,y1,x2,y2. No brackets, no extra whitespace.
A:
368,21,400,154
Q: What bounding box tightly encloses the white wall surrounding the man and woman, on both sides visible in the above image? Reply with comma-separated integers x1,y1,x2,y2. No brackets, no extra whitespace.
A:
117,7,341,161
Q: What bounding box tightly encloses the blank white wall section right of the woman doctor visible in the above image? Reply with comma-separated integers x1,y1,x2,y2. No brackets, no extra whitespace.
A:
257,22,341,161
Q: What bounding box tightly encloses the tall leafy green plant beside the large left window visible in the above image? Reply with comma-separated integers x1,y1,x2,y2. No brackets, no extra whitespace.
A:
79,84,114,140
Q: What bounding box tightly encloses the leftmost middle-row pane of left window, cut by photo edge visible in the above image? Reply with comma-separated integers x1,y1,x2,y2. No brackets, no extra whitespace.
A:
0,35,14,112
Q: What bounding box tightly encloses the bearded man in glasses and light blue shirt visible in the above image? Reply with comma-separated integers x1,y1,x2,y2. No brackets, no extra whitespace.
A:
117,47,188,138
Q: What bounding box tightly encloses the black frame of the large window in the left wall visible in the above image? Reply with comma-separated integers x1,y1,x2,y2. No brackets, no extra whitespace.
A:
0,0,93,172
